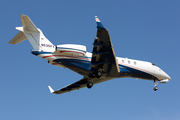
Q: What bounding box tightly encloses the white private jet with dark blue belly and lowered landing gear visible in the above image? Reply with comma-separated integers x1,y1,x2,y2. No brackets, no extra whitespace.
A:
9,14,171,94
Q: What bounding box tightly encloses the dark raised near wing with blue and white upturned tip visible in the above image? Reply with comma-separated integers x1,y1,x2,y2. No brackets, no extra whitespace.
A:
91,16,120,77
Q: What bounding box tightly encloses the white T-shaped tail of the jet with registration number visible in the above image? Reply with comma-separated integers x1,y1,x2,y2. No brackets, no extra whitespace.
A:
9,15,55,53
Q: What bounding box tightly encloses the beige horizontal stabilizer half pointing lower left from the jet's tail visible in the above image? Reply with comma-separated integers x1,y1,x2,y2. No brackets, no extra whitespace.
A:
9,31,27,45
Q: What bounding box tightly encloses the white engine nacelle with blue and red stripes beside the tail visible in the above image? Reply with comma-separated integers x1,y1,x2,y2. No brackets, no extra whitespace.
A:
56,44,86,56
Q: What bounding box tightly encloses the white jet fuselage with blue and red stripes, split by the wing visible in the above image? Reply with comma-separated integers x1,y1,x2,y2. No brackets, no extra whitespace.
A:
32,52,171,82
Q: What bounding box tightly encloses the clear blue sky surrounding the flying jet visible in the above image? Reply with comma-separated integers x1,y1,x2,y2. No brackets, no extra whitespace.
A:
0,0,180,120
